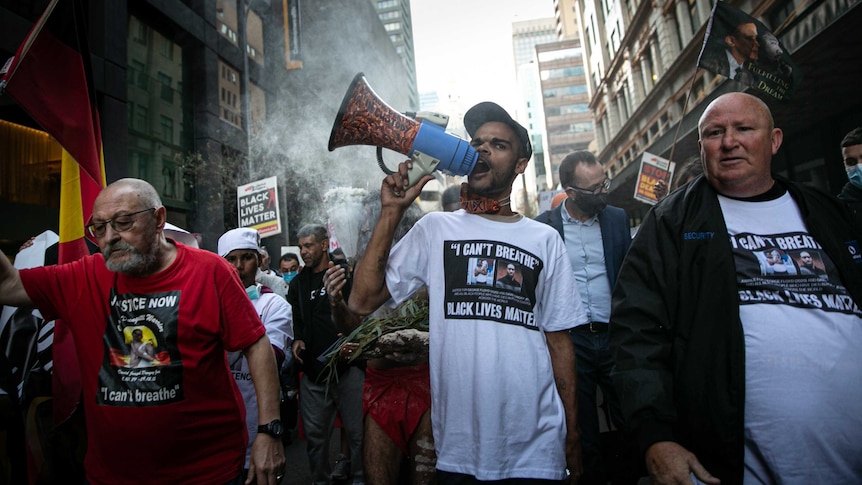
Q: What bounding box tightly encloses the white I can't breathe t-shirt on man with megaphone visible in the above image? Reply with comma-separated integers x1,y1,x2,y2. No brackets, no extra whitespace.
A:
386,210,587,480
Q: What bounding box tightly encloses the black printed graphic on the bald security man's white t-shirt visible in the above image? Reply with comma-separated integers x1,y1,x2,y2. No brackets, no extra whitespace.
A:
730,232,862,315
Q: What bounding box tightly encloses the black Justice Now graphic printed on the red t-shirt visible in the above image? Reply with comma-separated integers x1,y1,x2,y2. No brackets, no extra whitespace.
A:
96,289,183,406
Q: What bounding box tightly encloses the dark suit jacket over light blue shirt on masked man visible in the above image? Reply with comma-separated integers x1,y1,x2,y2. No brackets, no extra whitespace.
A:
536,203,632,290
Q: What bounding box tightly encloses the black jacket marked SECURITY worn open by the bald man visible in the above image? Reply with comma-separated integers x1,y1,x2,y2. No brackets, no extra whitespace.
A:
610,177,862,484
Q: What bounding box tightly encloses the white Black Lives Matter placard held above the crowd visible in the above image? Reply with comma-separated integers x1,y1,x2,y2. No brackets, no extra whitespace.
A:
236,177,281,237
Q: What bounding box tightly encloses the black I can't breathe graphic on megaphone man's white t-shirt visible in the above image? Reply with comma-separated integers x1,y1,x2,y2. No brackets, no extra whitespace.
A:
443,240,543,330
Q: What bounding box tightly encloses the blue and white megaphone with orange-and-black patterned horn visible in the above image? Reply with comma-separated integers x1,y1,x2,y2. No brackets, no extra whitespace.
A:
329,72,479,187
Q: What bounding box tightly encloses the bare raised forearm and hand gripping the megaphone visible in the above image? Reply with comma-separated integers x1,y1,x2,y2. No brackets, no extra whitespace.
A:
348,160,433,316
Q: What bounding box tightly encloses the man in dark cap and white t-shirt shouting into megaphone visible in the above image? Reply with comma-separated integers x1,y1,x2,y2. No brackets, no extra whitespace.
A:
328,102,588,484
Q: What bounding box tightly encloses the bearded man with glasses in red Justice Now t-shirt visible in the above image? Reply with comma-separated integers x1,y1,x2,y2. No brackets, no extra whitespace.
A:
0,179,284,485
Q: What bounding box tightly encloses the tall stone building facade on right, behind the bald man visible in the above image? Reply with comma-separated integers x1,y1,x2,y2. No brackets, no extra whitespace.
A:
554,0,862,225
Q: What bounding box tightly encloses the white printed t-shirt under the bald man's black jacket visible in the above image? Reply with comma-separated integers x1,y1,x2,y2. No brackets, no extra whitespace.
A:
719,194,862,484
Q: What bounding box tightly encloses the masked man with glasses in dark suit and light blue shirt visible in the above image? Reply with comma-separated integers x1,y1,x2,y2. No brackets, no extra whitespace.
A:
536,151,631,484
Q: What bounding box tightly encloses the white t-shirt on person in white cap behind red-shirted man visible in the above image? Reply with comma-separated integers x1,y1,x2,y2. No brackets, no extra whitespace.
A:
228,293,293,468
